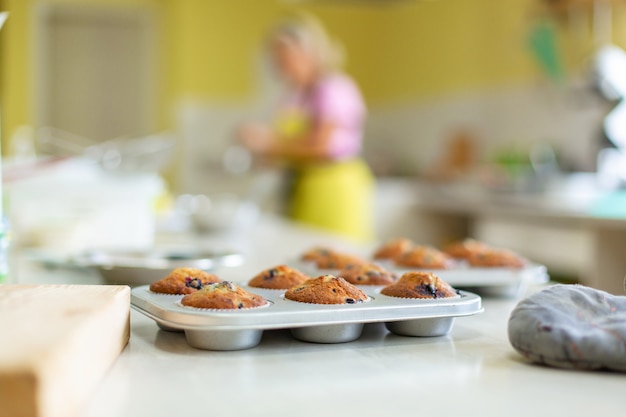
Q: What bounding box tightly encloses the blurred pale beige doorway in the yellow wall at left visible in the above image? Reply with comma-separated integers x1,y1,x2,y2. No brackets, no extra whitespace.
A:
33,5,156,142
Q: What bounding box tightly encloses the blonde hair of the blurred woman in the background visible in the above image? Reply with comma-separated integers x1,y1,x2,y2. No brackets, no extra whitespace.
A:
270,12,345,72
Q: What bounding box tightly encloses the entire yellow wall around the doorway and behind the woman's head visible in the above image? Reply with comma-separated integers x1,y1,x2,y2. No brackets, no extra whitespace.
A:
0,0,626,150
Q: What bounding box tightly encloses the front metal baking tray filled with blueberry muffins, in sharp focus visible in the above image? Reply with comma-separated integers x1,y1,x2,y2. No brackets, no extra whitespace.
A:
131,265,482,350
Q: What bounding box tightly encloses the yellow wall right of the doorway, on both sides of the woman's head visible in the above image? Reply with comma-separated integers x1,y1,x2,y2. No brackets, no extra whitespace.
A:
162,0,560,104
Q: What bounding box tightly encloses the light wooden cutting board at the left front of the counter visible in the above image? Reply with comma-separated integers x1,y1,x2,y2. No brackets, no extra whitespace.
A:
0,285,130,417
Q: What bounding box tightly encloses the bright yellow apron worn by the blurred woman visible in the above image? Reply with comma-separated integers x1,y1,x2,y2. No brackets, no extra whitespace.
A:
276,105,374,240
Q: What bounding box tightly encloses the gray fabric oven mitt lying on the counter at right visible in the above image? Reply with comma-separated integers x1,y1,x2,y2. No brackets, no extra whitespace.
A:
509,285,626,371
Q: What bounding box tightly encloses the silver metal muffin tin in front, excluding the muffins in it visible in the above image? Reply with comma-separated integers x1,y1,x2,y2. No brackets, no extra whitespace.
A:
131,284,483,350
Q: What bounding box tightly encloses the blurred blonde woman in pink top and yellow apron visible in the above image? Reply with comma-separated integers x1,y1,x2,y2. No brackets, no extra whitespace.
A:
240,15,374,240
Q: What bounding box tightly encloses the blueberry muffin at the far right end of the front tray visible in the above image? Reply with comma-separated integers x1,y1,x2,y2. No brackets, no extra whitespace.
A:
380,271,458,299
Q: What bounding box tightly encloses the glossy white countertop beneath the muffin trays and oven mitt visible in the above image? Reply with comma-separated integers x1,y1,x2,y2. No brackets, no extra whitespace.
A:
14,214,626,417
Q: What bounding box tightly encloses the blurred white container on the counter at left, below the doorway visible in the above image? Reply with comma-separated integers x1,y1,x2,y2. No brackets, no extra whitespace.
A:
6,159,164,253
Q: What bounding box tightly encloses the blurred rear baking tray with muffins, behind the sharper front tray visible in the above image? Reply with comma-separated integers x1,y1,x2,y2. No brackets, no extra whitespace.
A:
295,237,549,297
